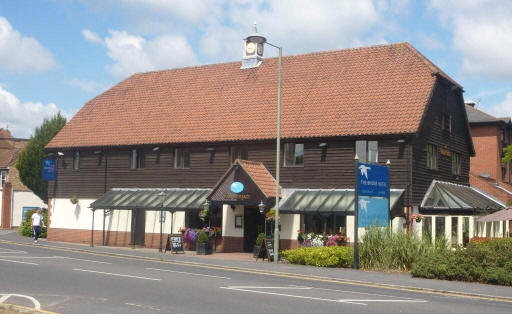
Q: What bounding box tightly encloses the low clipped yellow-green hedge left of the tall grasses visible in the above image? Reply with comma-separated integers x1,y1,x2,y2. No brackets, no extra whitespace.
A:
282,246,354,267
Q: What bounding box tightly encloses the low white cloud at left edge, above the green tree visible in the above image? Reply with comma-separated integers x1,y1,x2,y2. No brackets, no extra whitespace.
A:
0,86,71,138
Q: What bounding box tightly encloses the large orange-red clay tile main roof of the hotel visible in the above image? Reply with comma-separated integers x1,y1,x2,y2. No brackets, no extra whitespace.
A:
47,43,459,148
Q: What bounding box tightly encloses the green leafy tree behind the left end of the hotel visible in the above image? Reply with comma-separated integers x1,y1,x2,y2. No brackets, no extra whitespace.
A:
16,112,66,203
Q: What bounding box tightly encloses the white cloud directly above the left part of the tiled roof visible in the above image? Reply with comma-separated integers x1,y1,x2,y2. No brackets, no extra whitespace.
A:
82,30,197,77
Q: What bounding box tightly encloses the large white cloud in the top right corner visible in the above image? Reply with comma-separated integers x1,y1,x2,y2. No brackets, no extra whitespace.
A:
430,0,512,80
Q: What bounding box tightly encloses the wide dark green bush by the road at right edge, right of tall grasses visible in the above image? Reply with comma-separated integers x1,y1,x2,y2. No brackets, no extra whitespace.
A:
411,238,512,286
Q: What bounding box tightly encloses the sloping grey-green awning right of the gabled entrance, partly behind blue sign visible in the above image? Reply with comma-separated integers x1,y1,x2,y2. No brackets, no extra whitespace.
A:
279,189,404,214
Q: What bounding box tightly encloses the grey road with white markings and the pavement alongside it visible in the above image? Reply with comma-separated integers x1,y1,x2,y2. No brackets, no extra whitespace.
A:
0,232,512,314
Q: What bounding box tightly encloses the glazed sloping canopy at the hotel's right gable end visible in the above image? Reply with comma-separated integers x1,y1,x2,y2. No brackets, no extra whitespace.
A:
421,180,505,214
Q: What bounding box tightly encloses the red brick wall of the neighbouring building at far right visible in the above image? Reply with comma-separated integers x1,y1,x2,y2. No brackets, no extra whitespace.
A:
470,126,502,181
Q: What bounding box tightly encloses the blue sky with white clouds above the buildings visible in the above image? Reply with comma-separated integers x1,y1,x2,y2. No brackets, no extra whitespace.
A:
0,0,512,138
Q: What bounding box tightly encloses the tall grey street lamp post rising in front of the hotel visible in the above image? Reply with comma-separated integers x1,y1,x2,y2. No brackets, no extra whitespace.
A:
245,23,283,263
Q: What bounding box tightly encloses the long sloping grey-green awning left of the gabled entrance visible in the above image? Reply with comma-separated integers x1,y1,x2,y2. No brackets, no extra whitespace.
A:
90,188,210,211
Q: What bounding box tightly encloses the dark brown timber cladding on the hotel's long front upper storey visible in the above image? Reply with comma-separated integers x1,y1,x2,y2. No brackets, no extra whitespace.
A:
48,137,410,198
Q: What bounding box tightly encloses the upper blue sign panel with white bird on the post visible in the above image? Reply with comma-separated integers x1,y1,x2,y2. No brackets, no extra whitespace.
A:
357,163,389,198
